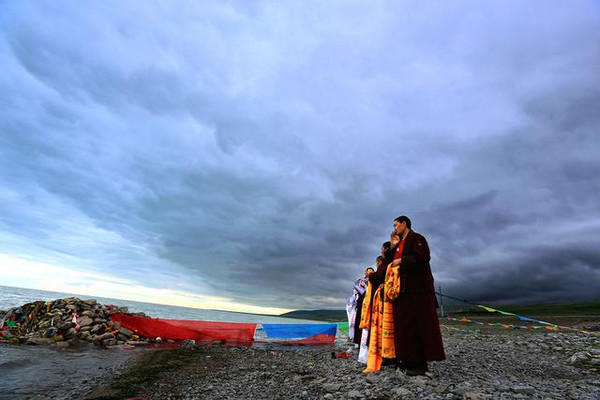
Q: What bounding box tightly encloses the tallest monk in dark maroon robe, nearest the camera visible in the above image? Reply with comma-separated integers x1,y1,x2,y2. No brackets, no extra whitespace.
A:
392,215,446,376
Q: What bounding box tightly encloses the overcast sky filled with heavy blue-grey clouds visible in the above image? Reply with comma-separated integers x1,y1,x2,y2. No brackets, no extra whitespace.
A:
0,0,600,312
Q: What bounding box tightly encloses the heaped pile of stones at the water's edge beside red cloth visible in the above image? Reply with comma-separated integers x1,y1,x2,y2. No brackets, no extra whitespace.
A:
0,297,149,346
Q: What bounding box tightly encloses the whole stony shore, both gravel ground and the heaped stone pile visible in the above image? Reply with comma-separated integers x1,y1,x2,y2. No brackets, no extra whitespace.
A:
0,298,600,400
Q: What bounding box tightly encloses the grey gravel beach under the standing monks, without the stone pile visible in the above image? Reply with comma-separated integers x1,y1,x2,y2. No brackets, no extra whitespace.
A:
81,329,600,399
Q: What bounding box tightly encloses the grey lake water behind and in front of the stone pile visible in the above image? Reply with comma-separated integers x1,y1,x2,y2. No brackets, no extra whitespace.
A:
0,286,328,399
